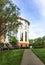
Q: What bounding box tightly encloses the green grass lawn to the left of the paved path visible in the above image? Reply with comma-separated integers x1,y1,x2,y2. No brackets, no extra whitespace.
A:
0,49,24,65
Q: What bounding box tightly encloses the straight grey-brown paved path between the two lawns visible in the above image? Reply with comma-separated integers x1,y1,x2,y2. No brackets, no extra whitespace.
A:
21,49,44,65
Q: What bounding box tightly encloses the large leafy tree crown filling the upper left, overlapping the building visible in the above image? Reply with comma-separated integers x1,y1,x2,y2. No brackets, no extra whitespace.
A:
0,0,21,36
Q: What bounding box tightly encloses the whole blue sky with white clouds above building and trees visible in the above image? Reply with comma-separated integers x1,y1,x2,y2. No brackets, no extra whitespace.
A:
12,0,45,39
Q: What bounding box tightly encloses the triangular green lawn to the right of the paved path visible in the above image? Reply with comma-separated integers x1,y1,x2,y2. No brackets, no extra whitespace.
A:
32,48,45,64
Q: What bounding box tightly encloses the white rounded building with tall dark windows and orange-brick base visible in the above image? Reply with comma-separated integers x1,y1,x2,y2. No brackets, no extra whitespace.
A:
17,17,30,47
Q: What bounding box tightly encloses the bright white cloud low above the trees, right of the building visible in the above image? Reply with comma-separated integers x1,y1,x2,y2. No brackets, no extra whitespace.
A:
29,30,45,39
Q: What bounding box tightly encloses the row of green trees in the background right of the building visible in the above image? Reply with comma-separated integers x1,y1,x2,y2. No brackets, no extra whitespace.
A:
29,36,45,47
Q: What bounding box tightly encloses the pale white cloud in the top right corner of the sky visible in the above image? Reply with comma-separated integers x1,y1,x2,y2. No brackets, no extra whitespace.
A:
33,0,45,16
